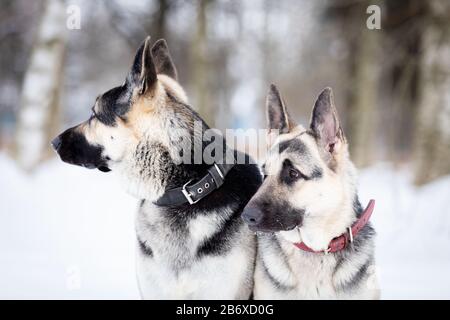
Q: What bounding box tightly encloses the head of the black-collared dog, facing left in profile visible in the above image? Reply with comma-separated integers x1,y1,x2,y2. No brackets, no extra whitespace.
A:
52,37,199,198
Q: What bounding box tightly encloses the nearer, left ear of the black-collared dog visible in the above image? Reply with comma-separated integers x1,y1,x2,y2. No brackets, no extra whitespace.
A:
128,36,157,94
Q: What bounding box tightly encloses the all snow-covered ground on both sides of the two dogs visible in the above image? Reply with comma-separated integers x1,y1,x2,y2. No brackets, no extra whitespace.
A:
0,153,450,299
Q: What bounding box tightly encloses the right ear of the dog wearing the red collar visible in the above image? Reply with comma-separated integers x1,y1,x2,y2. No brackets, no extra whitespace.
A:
310,87,345,154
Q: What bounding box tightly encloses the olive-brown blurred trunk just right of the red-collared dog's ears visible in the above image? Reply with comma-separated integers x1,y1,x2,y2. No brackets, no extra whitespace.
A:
327,0,382,166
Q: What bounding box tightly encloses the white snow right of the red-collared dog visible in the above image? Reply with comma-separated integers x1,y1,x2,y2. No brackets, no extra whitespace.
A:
360,165,450,299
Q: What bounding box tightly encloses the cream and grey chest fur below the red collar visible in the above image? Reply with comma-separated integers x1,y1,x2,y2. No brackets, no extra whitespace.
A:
255,227,379,299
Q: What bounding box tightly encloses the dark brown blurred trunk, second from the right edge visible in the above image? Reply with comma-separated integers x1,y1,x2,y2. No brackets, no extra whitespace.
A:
381,0,426,164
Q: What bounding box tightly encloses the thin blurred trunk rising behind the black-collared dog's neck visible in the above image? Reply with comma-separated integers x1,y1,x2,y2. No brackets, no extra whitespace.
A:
192,0,212,127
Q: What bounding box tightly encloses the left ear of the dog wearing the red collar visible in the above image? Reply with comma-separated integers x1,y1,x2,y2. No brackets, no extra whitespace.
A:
266,84,292,134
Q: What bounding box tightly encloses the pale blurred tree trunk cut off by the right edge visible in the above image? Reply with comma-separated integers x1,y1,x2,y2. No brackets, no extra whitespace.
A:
414,0,450,184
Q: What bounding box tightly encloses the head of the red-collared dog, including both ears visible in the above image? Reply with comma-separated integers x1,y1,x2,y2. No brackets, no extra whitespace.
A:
243,85,349,232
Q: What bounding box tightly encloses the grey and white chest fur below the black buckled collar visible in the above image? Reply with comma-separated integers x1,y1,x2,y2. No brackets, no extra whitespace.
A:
136,199,255,299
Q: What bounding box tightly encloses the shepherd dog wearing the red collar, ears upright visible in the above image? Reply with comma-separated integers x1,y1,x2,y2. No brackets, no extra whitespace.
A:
243,85,379,299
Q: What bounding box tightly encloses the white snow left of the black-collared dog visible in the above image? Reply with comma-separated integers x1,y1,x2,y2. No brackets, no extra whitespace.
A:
0,154,139,299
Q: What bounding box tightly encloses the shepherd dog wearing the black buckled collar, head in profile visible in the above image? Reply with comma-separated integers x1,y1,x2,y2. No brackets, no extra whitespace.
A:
52,38,261,299
